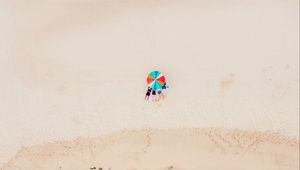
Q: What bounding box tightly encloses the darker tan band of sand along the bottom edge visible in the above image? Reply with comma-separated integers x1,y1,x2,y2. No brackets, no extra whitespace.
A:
1,129,299,170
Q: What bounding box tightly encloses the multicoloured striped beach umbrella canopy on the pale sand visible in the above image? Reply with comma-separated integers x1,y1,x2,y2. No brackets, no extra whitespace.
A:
147,71,166,90
